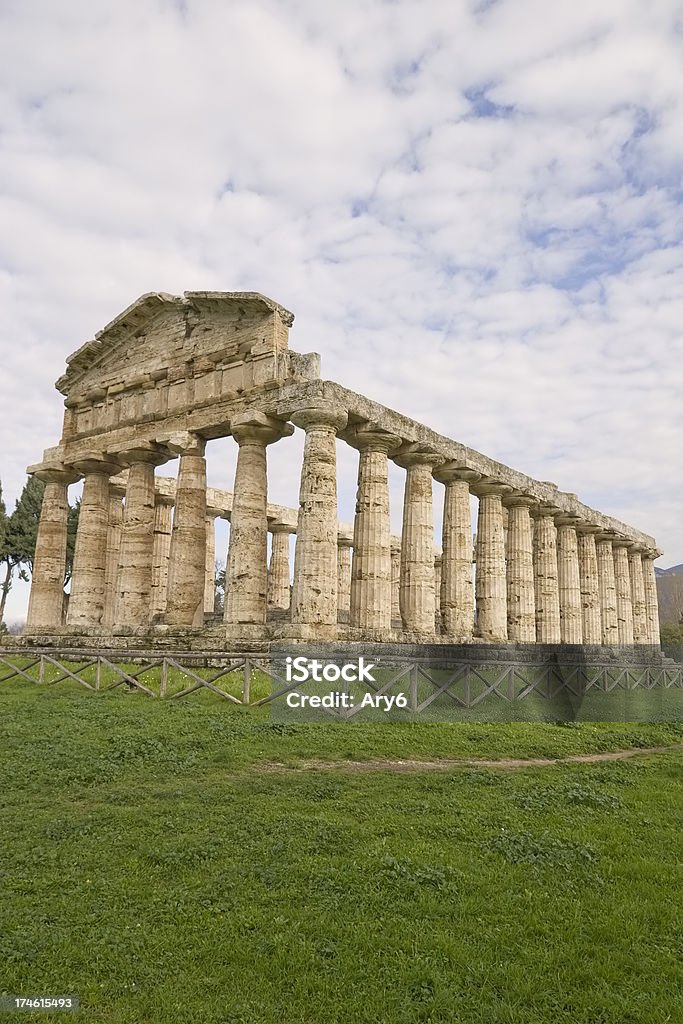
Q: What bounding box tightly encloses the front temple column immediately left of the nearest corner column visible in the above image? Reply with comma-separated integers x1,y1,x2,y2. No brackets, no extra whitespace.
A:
224,410,292,634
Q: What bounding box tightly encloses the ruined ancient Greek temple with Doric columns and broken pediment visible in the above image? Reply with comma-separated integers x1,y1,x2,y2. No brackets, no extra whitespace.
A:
26,292,661,646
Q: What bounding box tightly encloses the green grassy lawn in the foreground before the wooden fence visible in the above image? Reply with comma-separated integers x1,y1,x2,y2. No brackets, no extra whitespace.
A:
0,680,683,1024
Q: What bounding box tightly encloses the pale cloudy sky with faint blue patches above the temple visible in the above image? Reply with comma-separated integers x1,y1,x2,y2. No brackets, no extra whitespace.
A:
0,0,683,621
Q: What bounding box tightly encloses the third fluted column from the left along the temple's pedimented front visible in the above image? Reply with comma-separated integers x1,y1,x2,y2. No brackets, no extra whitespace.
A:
115,446,168,629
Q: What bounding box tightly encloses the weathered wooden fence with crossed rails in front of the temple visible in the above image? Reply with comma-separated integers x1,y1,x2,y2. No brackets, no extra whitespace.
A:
0,649,683,718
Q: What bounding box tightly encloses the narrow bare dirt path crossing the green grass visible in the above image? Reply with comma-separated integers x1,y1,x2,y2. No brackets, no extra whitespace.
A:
257,743,683,772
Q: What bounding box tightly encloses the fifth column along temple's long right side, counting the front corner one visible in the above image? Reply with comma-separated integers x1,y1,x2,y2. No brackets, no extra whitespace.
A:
472,477,512,642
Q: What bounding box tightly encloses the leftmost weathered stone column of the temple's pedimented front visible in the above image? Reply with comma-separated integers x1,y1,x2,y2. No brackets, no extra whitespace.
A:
27,466,79,632
